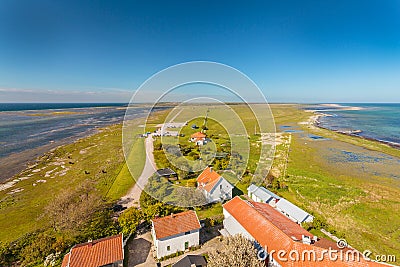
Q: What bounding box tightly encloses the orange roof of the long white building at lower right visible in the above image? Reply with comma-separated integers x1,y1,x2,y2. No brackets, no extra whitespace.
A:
223,197,382,267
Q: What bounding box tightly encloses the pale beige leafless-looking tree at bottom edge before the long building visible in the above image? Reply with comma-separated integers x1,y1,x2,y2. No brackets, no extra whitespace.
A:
207,235,265,267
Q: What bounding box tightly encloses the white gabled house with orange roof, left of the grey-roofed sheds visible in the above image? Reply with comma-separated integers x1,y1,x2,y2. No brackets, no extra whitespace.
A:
197,167,234,203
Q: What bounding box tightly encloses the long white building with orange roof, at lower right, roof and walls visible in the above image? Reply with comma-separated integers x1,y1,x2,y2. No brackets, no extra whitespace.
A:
223,197,380,267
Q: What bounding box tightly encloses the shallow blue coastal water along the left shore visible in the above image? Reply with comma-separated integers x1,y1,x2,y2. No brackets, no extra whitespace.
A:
0,104,153,182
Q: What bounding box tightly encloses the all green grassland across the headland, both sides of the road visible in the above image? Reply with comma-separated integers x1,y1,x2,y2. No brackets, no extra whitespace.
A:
0,104,400,264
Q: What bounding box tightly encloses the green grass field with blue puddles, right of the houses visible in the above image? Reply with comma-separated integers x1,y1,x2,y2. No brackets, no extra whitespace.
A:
272,106,400,258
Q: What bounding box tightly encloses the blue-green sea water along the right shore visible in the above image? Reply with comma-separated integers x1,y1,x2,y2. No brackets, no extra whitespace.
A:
307,104,400,145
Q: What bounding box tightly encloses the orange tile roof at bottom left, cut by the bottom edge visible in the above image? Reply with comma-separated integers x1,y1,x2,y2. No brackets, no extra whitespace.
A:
61,234,124,267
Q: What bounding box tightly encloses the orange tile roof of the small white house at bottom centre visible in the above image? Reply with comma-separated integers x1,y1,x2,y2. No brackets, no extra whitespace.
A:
153,210,201,239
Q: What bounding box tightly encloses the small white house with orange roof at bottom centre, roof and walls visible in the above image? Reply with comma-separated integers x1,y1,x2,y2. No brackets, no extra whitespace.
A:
151,210,201,258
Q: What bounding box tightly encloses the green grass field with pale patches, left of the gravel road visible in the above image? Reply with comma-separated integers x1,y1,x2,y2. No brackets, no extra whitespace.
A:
0,120,144,242
